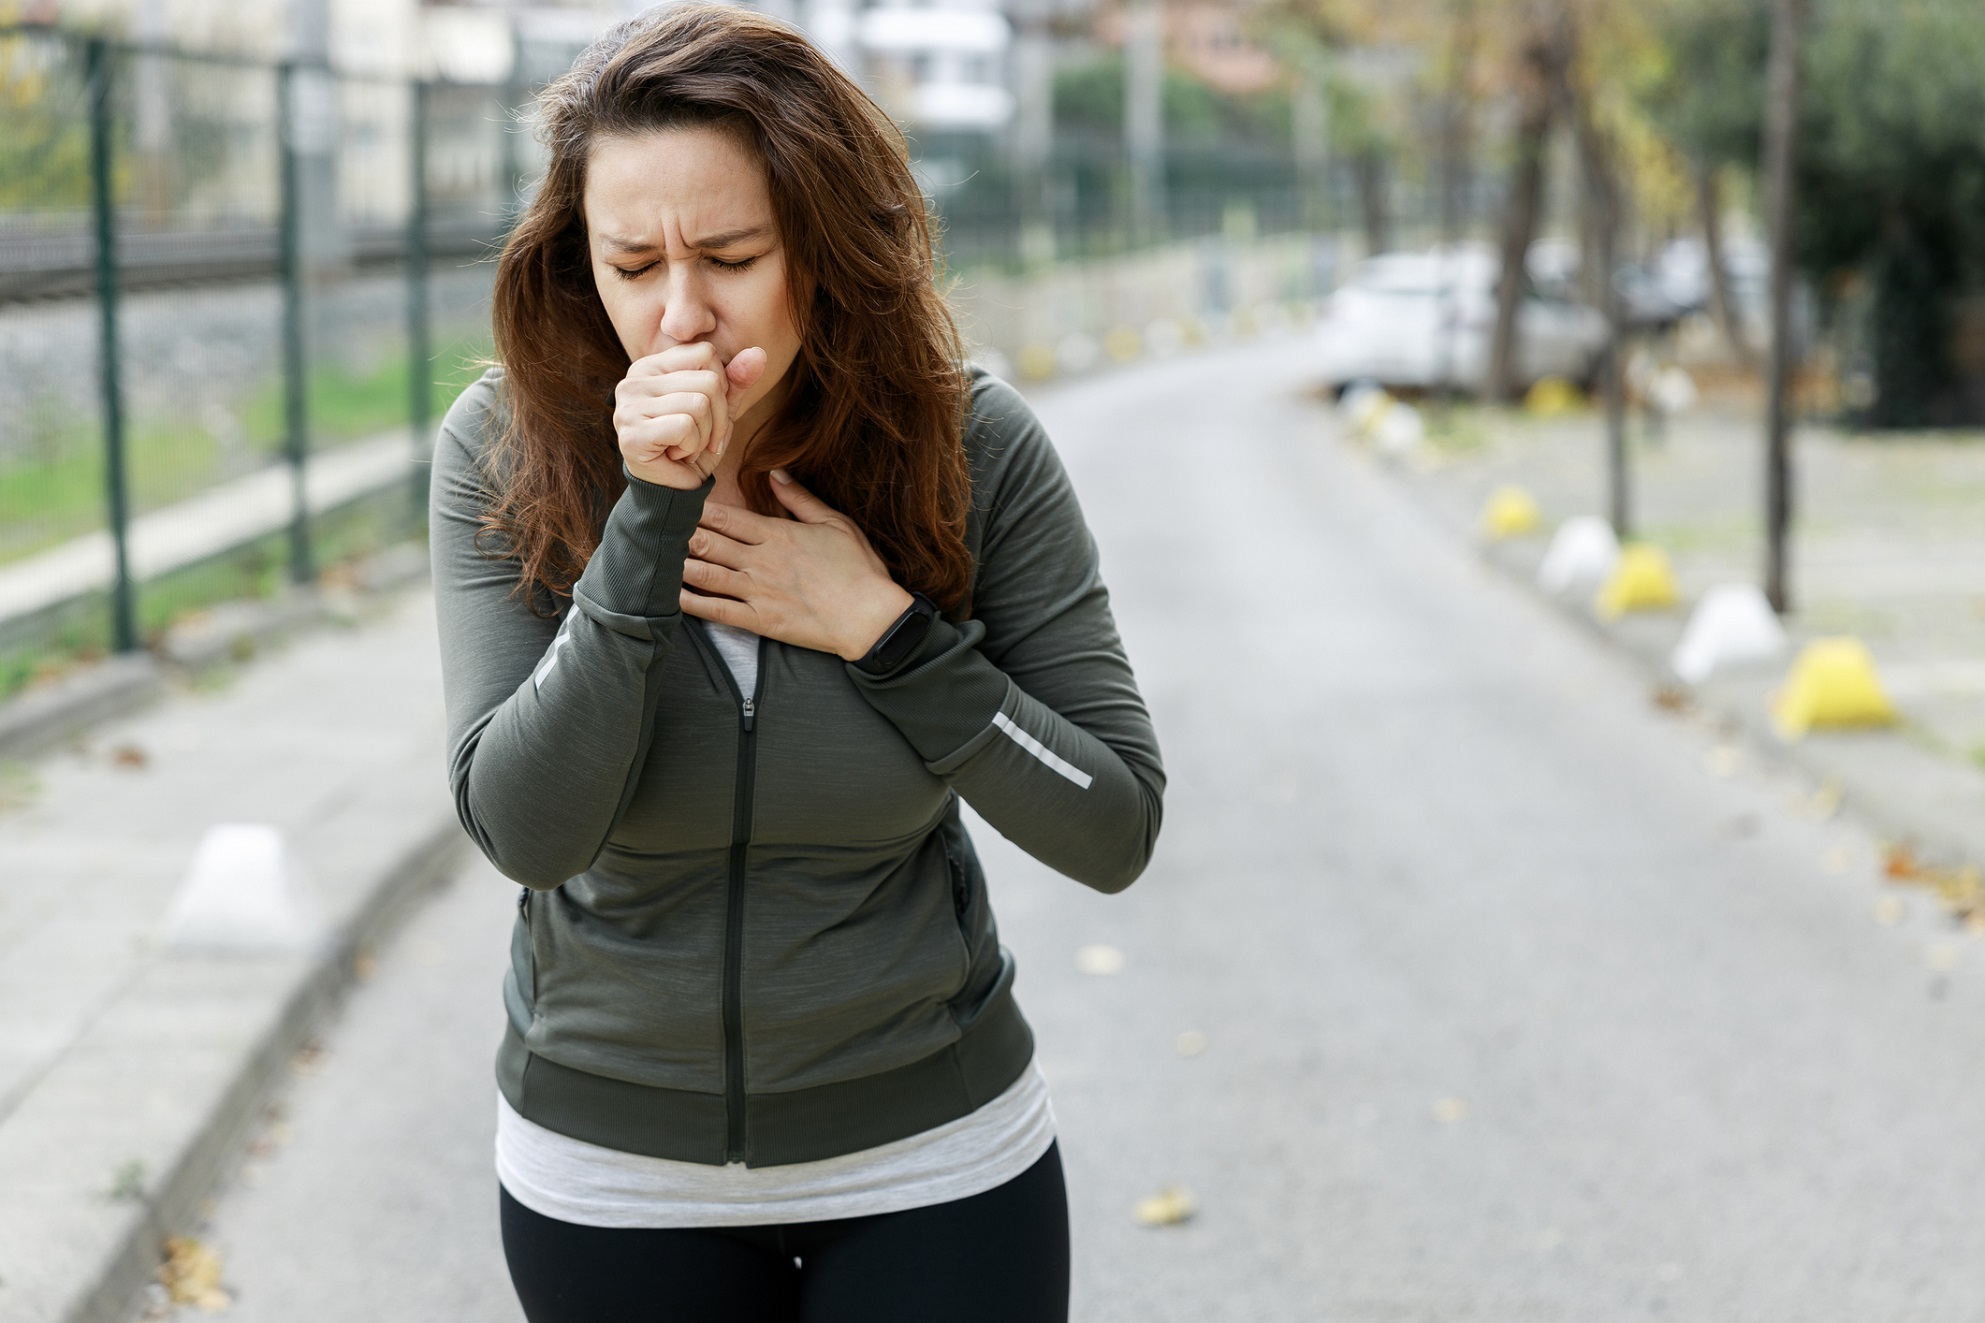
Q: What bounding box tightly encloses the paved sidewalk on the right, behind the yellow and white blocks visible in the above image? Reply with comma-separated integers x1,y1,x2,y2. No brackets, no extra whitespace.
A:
1399,403,1985,862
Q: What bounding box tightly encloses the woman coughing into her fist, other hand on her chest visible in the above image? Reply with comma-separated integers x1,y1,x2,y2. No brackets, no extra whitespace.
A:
433,8,1163,1323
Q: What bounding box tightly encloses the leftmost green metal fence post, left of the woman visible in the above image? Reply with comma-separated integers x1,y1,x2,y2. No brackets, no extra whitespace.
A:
83,38,137,652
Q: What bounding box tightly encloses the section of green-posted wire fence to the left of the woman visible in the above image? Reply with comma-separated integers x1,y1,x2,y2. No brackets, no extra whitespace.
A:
0,28,512,693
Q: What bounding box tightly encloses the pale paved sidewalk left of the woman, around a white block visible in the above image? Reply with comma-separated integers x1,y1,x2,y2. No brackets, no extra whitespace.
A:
0,588,459,1323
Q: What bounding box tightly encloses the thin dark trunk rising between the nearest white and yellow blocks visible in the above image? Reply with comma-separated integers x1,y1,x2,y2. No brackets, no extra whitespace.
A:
1765,0,1806,612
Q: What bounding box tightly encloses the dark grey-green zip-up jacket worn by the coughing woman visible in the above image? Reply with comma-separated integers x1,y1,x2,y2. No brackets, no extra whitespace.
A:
431,371,1165,1166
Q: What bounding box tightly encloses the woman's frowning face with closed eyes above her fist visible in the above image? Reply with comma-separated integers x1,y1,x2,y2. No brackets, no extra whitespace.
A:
584,127,800,417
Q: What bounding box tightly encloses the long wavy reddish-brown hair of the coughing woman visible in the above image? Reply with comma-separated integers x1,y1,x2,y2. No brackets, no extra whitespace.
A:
484,4,973,614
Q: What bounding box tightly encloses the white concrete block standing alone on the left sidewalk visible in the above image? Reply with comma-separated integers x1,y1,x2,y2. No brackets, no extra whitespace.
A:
163,822,326,954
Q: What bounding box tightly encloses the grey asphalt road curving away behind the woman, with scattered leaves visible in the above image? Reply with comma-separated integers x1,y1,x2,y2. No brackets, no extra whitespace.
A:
178,335,1985,1323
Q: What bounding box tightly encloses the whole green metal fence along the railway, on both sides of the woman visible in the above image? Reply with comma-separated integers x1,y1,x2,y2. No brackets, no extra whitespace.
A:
0,26,1346,695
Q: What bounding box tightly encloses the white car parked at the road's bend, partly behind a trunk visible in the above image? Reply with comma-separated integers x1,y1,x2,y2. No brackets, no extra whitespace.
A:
1316,244,1606,391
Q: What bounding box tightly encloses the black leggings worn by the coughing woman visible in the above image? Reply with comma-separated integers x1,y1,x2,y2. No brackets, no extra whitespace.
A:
502,1146,1068,1323
